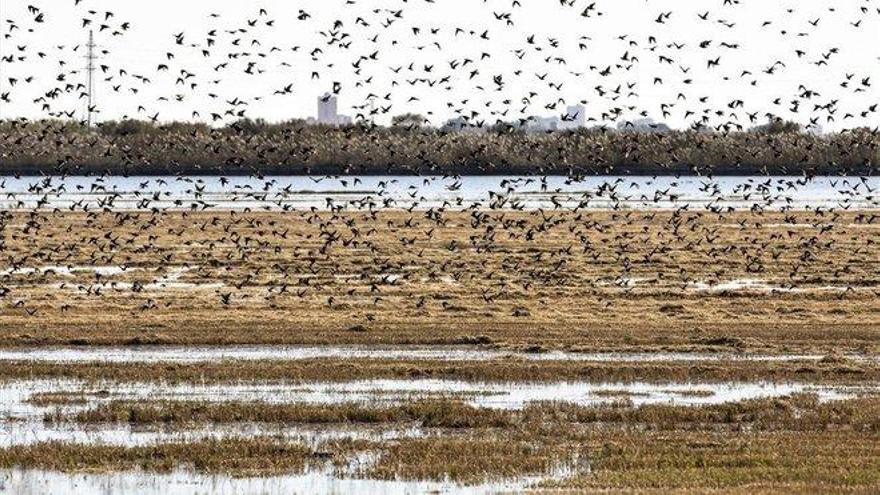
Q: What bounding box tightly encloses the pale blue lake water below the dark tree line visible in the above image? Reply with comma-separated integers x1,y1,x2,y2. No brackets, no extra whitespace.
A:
0,176,880,210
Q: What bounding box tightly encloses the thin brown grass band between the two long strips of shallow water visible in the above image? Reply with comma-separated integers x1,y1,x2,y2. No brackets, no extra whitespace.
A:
0,359,880,384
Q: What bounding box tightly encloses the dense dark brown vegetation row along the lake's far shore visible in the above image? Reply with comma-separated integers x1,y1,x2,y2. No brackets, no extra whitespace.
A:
0,120,880,176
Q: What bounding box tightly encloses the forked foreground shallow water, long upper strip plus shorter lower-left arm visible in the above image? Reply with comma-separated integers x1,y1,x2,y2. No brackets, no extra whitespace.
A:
0,379,880,454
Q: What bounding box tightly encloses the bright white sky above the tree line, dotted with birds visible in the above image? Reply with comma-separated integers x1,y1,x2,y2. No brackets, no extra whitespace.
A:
0,0,880,130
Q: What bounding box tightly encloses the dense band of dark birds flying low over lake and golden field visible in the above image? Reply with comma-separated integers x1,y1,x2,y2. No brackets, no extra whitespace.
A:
0,177,880,322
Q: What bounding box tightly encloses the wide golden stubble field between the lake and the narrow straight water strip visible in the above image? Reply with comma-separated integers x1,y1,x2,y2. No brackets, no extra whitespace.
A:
0,211,880,353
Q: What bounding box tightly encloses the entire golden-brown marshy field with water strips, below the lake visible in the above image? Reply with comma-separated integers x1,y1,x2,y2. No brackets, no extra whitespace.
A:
0,200,880,493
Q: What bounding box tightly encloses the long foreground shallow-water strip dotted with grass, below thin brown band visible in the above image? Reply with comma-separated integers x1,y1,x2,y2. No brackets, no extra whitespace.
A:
0,379,880,419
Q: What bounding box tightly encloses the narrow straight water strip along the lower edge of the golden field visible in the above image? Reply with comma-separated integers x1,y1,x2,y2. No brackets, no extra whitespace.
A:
0,345,860,363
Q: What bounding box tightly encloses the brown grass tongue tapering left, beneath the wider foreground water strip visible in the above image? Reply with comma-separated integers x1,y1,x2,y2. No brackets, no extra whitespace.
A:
45,394,880,434
